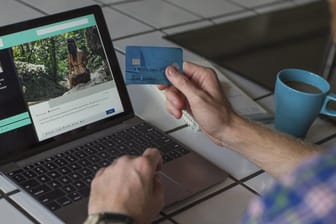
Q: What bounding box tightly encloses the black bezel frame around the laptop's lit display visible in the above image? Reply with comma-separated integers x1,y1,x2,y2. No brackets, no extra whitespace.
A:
0,5,134,164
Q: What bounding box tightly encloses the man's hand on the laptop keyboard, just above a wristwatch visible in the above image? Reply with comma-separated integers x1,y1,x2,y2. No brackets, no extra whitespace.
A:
89,149,164,224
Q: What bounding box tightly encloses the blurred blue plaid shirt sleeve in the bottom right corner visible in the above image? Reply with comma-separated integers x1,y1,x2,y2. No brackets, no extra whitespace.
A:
243,149,336,224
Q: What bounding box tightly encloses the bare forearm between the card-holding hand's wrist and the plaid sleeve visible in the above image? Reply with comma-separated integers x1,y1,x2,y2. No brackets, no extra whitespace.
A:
221,116,320,177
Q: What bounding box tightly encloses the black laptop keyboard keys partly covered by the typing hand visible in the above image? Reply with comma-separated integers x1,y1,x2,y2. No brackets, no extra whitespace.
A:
7,123,189,211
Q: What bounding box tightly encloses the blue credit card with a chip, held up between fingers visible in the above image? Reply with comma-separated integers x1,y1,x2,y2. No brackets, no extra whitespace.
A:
125,46,183,84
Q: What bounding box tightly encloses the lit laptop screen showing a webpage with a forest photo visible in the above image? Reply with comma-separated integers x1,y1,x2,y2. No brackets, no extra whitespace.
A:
0,7,133,163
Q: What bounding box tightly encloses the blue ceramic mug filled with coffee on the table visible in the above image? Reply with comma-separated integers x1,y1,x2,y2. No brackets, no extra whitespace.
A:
274,68,336,138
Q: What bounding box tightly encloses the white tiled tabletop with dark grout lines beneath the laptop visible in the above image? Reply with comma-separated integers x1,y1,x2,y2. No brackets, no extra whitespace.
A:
0,0,336,224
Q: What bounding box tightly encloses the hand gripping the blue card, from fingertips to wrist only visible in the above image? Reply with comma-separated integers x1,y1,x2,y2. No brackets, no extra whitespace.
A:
159,62,235,144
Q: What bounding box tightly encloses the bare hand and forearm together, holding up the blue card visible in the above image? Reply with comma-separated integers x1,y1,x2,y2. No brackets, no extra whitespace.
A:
159,60,318,177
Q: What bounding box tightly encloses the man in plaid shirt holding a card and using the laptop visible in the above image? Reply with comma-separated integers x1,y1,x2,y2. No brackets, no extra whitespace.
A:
84,62,336,224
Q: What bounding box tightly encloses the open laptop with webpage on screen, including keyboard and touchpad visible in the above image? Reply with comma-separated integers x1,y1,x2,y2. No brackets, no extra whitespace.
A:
0,5,227,223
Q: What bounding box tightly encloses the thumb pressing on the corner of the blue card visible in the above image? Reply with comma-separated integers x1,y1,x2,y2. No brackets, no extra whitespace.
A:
166,66,198,99
